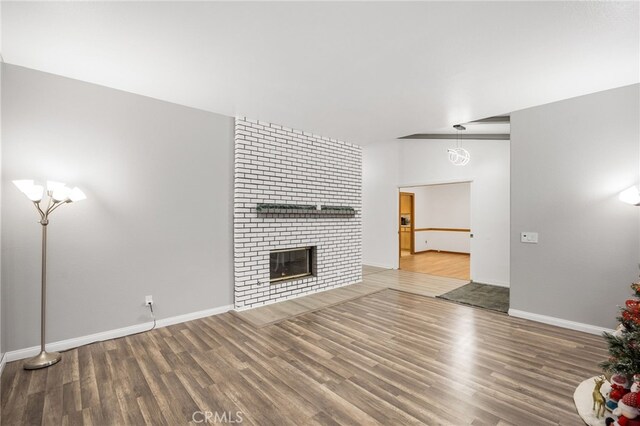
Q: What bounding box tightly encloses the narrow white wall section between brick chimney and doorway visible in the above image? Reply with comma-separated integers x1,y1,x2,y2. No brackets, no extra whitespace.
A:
362,141,399,268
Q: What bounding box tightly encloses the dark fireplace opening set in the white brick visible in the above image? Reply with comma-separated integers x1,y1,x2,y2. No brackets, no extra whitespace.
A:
269,247,315,283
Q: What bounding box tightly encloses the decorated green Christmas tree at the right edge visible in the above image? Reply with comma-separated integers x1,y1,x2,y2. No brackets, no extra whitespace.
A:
600,282,640,378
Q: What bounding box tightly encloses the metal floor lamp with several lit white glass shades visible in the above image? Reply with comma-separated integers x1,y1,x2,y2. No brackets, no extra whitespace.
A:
13,180,87,370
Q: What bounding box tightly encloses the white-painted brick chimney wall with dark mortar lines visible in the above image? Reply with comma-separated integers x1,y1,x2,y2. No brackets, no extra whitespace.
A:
233,118,362,309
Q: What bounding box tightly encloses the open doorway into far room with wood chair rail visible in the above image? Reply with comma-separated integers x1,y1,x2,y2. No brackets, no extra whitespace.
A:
398,182,472,280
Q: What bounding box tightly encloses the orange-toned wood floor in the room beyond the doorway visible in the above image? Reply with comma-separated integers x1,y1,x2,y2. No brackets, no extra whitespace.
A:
400,251,471,280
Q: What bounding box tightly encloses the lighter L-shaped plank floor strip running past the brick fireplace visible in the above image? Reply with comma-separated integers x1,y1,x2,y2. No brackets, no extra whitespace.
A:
233,265,468,327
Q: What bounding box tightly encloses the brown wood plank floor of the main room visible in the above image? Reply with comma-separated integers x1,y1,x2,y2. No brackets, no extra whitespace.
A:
0,288,606,426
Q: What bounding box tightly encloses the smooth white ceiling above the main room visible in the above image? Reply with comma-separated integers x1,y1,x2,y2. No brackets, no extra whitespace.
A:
2,2,640,144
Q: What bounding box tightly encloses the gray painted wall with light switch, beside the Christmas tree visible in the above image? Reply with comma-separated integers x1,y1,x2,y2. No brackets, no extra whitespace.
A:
511,85,640,328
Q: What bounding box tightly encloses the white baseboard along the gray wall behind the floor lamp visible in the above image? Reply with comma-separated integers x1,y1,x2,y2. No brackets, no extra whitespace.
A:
3,305,233,362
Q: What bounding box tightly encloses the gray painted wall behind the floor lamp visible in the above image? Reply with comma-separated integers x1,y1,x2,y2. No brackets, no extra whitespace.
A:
2,65,234,351
